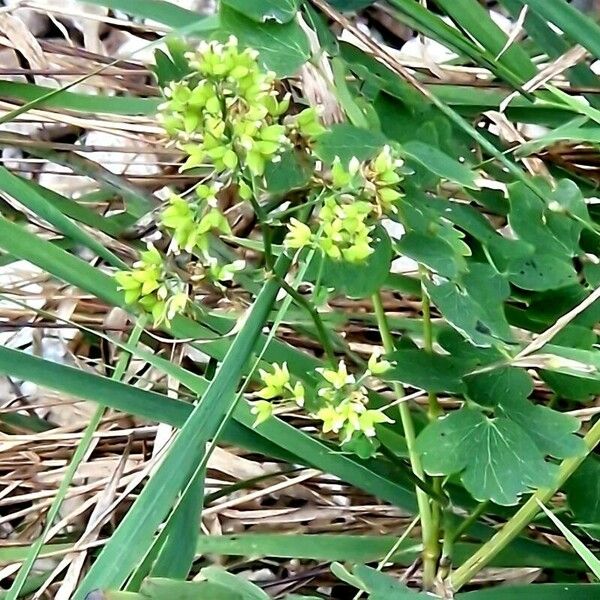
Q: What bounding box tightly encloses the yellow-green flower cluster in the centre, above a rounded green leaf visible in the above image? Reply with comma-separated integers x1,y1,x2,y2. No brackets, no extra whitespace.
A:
285,146,402,263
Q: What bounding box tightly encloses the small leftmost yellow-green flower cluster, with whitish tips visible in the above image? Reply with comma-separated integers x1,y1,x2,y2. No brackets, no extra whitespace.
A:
115,245,188,326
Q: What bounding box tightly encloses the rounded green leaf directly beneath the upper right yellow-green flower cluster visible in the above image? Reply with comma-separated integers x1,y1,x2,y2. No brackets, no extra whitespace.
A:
318,225,392,298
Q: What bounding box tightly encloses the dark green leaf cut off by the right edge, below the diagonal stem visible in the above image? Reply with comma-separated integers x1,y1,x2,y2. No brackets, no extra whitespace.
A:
564,454,600,540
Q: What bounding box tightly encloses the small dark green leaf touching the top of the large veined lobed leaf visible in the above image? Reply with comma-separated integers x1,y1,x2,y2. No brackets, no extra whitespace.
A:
465,367,533,407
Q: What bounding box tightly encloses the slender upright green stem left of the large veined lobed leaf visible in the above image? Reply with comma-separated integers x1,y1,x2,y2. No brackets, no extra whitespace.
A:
371,292,437,589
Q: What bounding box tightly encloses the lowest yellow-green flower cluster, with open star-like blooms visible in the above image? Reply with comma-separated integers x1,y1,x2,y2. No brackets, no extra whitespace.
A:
252,354,392,458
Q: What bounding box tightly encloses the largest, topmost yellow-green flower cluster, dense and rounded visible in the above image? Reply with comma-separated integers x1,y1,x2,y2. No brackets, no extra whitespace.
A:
160,37,289,176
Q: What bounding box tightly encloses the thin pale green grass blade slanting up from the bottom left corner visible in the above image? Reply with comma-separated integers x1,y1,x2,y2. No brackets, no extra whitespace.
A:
5,317,145,600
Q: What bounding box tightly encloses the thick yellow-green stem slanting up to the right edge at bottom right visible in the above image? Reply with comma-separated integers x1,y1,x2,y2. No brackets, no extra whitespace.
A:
450,421,600,590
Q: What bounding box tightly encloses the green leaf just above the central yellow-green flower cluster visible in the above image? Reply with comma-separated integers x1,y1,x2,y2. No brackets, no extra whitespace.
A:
315,123,386,165
